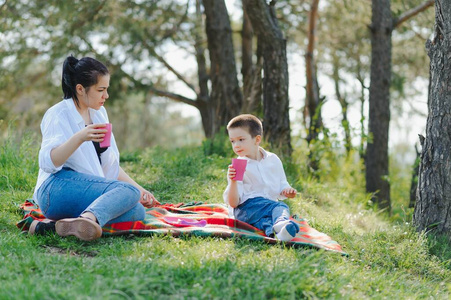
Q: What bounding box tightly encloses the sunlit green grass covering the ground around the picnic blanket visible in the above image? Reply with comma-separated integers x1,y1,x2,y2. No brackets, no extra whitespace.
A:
0,137,451,299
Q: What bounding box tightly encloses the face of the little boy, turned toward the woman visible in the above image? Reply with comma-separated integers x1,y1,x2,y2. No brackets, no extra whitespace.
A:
228,127,261,159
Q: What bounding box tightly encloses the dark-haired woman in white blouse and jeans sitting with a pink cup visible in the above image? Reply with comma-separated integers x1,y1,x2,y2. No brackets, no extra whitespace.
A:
30,56,159,241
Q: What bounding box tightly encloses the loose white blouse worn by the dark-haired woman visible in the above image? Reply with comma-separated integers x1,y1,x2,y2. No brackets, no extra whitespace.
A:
33,99,119,198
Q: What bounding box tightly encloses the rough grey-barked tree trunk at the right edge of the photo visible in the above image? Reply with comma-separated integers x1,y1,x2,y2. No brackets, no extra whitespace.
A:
413,1,451,236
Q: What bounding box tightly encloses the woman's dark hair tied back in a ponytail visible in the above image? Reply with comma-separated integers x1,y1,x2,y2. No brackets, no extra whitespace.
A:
62,55,109,106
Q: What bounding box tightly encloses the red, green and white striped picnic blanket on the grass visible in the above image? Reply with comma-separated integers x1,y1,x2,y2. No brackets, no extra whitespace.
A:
16,200,347,255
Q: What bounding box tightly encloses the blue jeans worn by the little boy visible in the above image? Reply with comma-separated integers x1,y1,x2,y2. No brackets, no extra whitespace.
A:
234,197,290,236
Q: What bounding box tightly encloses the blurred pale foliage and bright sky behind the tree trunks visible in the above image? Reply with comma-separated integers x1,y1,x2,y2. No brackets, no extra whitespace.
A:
0,0,434,155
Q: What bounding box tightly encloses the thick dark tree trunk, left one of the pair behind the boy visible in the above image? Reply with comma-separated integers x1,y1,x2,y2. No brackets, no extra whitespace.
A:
203,0,243,137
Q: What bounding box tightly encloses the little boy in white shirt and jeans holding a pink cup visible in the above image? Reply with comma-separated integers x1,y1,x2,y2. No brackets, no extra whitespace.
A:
223,114,299,241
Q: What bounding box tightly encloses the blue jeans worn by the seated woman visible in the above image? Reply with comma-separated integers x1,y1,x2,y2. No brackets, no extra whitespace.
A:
36,168,146,226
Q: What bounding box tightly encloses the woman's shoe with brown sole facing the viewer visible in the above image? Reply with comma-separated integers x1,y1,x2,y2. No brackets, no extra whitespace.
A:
55,217,102,241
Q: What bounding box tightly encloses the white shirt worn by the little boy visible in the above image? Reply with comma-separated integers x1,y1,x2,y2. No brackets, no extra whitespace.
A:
223,147,291,216
